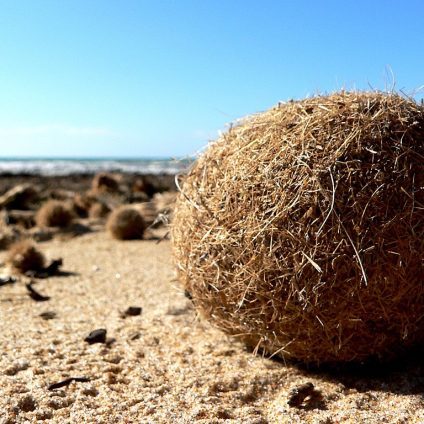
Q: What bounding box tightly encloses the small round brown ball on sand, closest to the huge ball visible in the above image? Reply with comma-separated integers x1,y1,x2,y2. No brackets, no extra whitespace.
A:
107,206,146,240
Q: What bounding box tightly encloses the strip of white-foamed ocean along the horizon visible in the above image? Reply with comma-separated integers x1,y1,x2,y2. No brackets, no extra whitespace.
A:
0,158,193,176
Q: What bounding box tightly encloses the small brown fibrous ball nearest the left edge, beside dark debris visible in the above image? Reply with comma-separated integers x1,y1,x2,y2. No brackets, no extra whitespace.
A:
6,240,45,274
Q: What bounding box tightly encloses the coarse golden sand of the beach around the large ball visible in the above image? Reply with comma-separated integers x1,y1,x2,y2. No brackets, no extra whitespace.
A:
0,174,424,424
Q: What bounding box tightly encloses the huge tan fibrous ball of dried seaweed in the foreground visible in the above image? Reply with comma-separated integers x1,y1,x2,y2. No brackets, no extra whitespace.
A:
172,92,424,363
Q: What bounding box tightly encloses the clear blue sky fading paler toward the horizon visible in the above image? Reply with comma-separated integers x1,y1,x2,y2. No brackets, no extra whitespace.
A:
0,0,424,157
